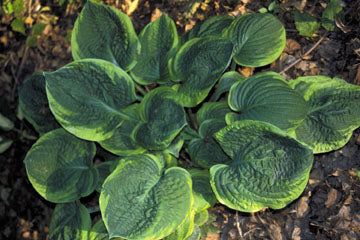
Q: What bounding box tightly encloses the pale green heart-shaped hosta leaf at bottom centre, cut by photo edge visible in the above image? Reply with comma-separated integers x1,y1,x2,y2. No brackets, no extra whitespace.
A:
100,155,193,240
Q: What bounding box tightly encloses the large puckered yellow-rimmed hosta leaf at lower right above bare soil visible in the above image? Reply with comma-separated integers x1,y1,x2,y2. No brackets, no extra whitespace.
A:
210,120,313,212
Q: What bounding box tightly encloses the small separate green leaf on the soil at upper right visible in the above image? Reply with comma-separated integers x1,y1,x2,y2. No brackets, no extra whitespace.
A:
294,9,320,37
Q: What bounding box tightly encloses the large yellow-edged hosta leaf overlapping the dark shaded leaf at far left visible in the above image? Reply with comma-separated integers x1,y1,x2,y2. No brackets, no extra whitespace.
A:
45,59,136,141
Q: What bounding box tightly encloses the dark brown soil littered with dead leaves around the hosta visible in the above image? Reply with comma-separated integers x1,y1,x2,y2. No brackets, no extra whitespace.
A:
0,0,360,240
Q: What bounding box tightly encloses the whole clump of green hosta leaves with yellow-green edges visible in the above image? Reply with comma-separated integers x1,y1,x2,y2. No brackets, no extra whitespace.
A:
20,1,360,239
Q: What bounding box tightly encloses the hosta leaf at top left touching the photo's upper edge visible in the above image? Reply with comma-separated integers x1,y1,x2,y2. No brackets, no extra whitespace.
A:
71,0,140,71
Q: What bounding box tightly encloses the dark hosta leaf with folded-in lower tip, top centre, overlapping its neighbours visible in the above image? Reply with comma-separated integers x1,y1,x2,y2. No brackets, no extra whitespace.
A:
169,37,233,107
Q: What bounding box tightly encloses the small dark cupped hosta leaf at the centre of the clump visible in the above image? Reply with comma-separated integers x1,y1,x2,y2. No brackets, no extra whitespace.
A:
133,87,186,150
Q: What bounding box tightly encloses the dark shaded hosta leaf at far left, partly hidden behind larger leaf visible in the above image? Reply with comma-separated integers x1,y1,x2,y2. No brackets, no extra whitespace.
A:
19,72,60,135
